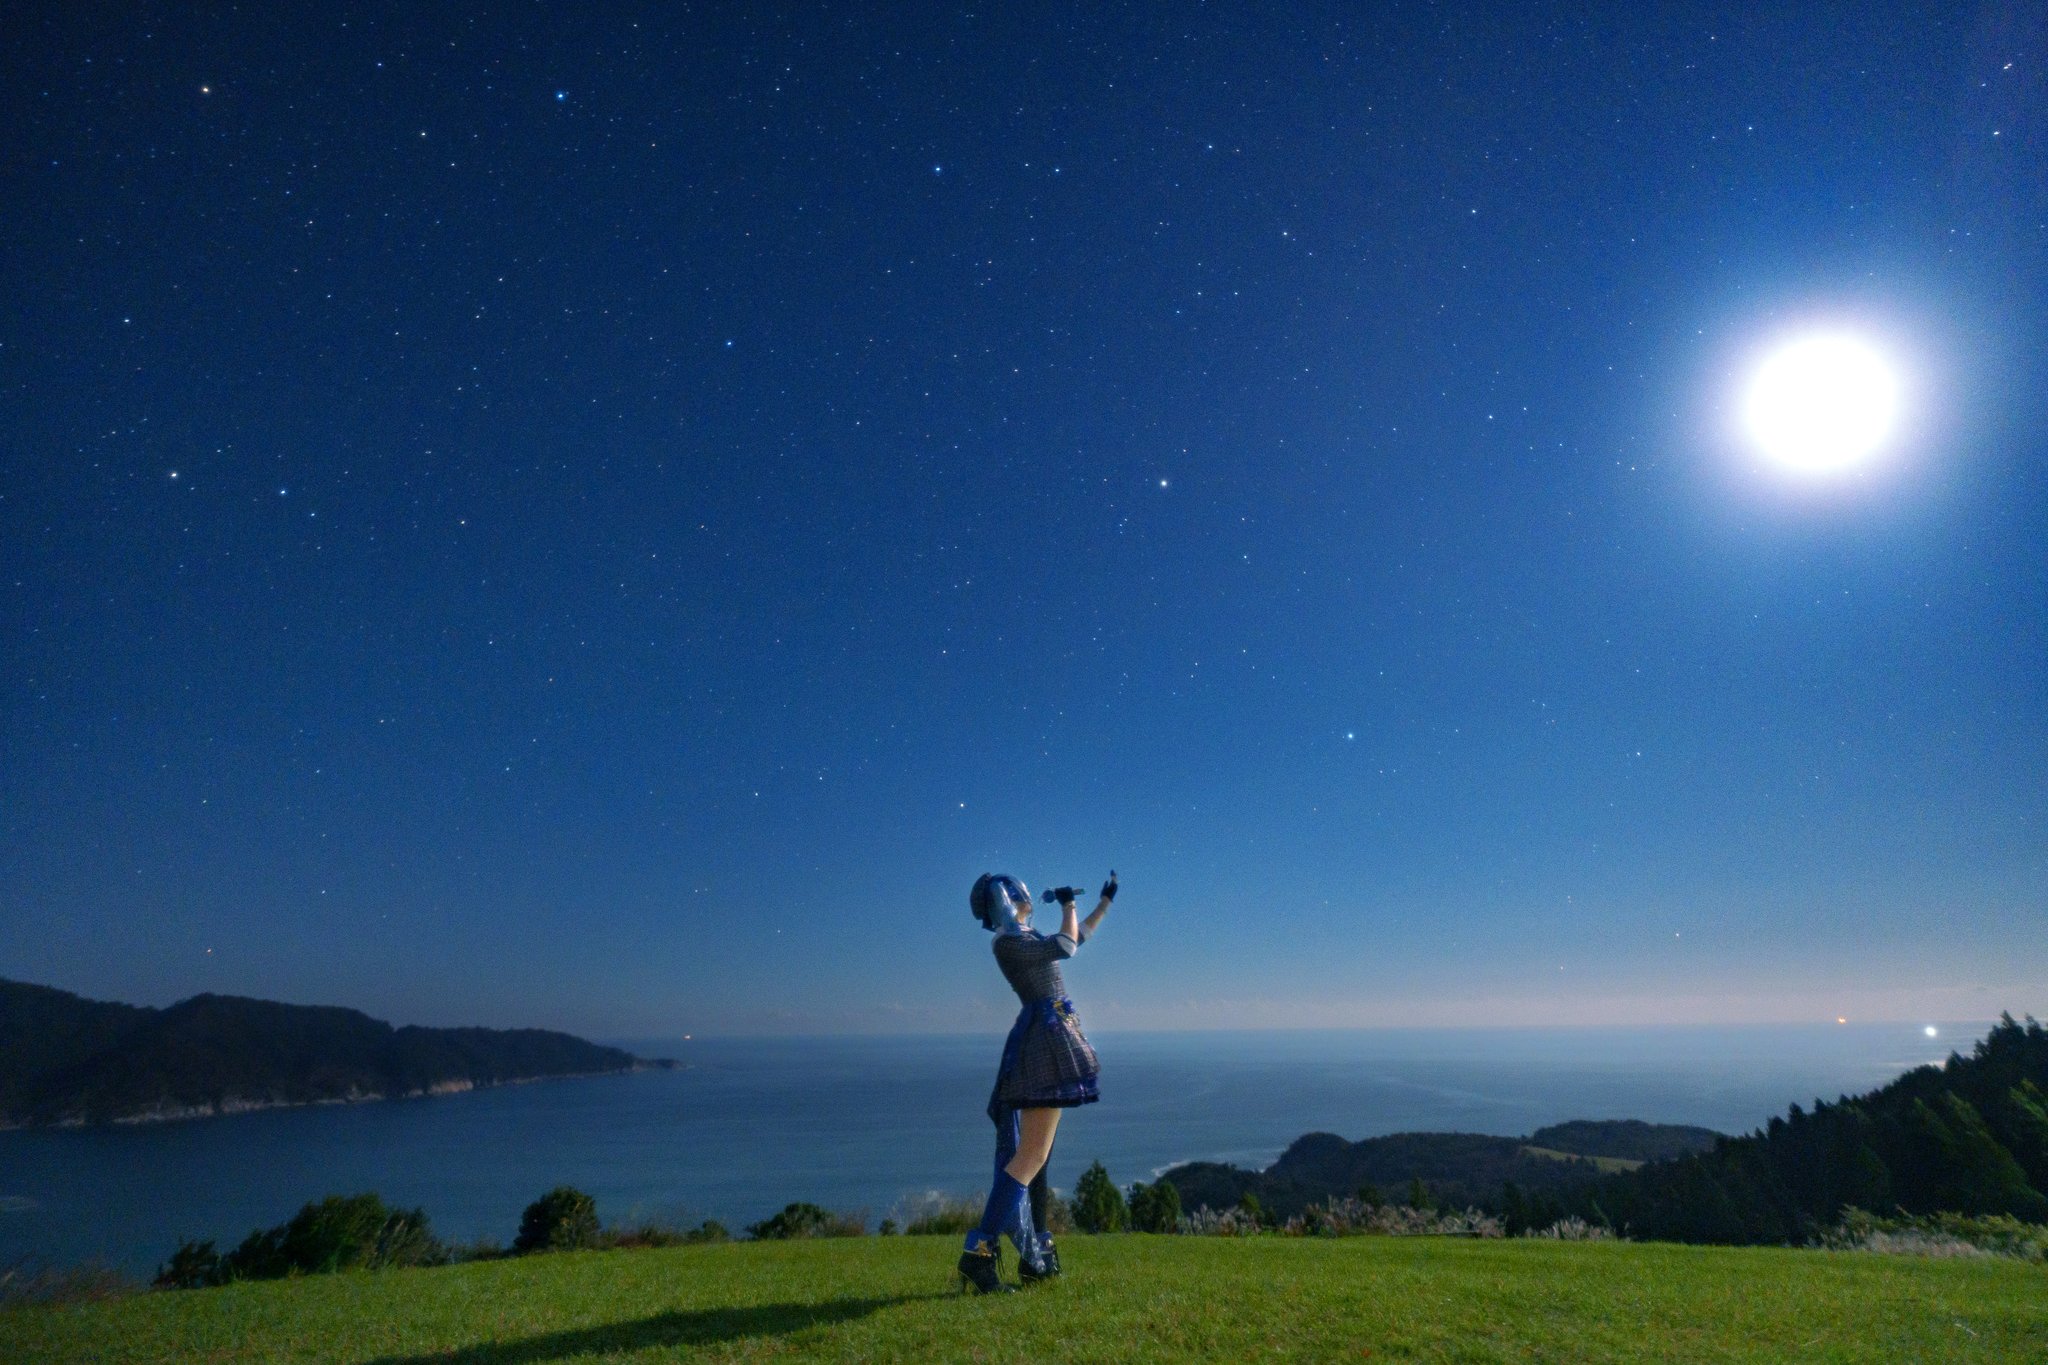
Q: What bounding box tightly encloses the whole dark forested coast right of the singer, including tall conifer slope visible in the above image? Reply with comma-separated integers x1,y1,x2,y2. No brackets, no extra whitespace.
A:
1163,1015,2048,1244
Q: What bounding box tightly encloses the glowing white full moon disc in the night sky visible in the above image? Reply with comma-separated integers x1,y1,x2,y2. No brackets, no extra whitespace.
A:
1743,332,1898,475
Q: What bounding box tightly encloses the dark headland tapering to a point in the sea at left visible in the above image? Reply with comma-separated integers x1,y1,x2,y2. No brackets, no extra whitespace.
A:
0,980,672,1128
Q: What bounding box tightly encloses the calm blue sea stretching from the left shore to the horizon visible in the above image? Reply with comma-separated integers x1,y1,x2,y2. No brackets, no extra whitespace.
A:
0,1023,1989,1275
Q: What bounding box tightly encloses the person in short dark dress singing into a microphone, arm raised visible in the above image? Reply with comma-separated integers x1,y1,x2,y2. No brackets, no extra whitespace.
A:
961,872,1116,1293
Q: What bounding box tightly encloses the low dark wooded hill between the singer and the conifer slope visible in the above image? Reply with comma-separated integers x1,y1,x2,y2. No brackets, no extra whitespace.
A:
1163,1119,1722,1218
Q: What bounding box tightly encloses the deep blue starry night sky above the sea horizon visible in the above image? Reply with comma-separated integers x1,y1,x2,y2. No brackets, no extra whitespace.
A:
0,0,2048,1036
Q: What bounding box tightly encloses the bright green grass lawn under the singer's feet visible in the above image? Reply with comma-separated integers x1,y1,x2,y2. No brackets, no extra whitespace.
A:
0,1236,2048,1365
